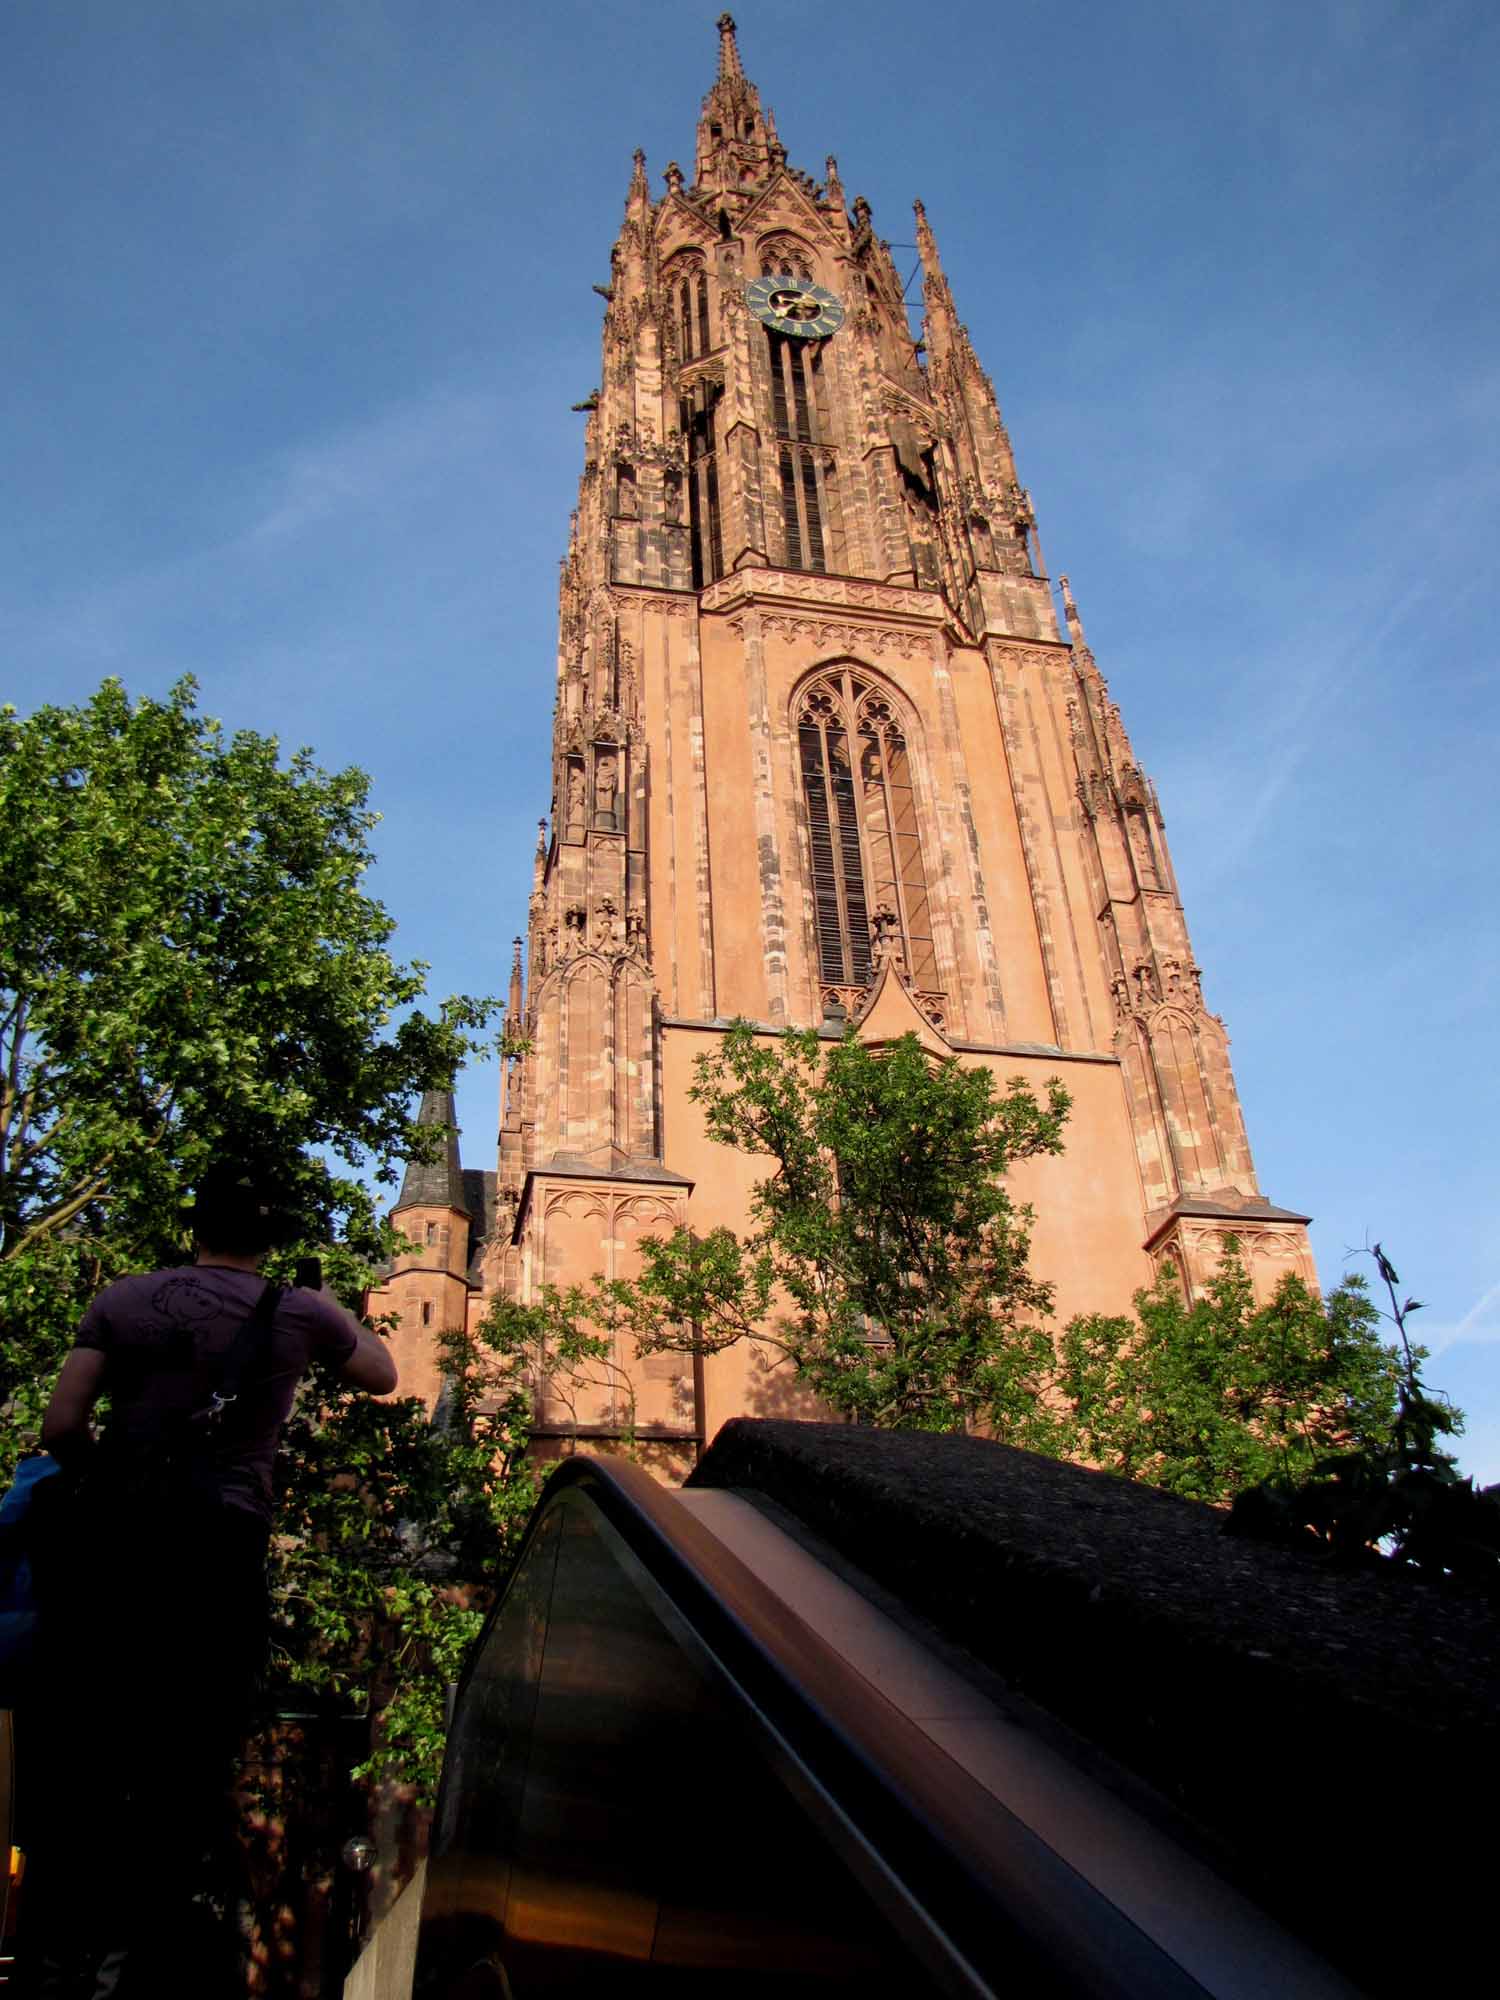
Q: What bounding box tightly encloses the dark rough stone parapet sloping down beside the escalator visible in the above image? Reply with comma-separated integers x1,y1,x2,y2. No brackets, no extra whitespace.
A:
688,1418,1500,1996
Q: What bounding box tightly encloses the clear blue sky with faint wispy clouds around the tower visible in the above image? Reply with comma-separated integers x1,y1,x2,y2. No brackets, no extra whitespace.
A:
0,0,1500,1478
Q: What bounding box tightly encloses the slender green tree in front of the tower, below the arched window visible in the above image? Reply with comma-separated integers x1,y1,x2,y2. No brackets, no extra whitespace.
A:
590,1022,1068,1444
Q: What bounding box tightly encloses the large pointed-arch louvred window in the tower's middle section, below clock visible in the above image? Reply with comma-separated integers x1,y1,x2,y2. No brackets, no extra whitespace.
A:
796,666,938,992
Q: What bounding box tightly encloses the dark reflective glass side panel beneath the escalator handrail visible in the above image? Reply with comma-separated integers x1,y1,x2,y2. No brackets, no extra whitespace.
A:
414,1492,930,2000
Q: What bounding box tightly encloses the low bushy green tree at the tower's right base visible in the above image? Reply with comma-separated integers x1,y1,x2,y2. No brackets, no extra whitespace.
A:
1058,1244,1400,1502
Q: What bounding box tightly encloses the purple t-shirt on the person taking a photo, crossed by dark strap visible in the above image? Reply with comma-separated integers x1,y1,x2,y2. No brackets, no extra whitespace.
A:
74,1264,356,1520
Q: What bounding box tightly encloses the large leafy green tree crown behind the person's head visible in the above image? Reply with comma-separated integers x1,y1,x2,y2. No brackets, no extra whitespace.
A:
0,680,490,1474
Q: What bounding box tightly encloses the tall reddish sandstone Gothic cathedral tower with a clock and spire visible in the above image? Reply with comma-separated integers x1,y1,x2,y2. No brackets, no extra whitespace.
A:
384,14,1312,1470
